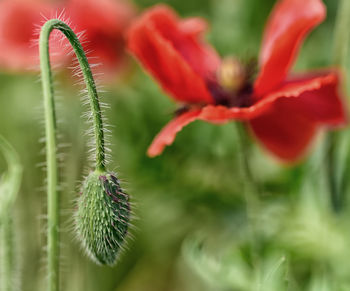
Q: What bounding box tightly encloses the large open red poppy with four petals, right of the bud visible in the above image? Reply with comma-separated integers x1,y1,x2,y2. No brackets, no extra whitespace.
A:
128,0,345,162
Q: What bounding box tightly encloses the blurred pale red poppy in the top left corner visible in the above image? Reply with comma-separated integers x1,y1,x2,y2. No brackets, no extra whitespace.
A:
0,0,66,71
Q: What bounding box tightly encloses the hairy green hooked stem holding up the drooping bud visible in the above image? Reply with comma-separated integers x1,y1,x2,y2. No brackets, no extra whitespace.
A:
39,19,105,291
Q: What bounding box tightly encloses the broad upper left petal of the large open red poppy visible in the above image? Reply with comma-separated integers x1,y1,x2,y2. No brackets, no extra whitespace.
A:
128,5,220,103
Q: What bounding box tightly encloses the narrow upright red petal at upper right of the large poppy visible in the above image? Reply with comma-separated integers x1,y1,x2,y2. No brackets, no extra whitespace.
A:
255,0,326,96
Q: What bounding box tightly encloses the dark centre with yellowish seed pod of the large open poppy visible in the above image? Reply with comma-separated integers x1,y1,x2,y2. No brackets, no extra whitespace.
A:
207,57,256,107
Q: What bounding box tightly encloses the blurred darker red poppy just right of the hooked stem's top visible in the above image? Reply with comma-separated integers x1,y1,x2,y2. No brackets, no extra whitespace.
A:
66,0,135,78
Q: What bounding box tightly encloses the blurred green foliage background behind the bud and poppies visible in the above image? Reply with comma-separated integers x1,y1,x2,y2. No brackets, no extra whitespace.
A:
0,0,350,291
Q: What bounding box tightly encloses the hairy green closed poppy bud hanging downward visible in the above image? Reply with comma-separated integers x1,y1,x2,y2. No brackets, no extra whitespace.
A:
76,171,130,265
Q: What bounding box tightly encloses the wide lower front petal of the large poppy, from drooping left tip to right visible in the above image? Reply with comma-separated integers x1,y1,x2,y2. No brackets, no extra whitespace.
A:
148,73,346,161
